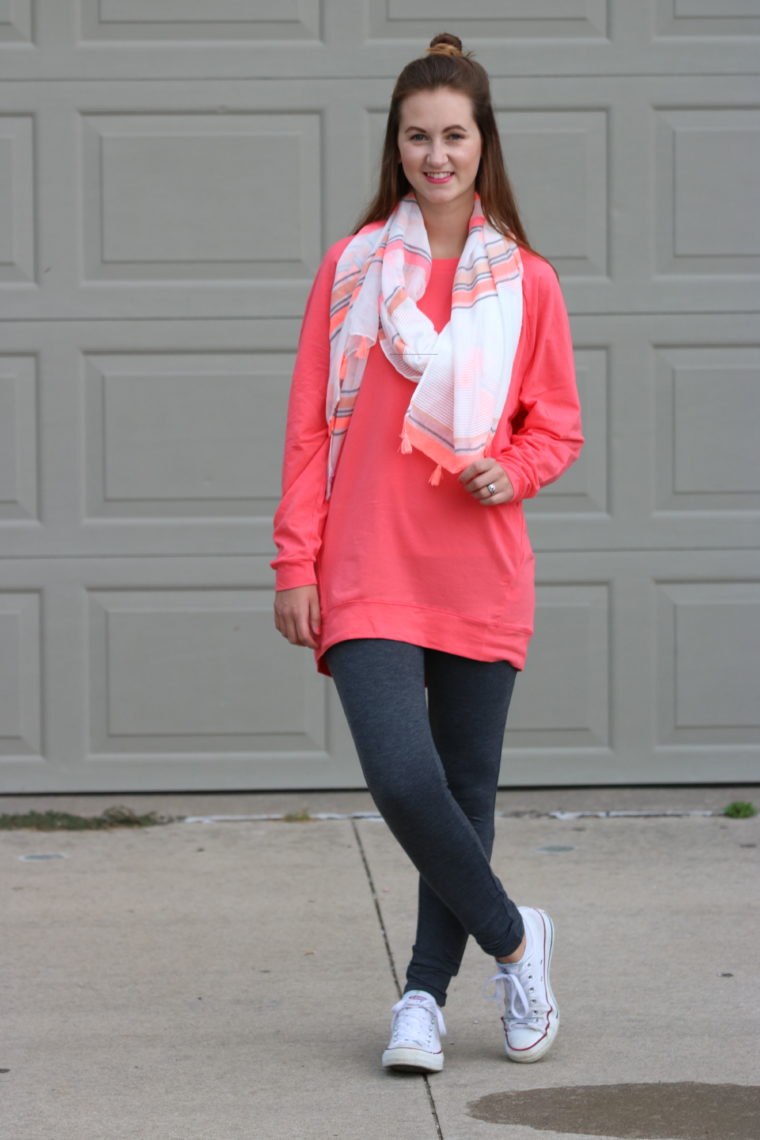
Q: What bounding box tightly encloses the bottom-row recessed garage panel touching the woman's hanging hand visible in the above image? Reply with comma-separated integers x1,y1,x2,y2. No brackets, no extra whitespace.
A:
89,586,325,755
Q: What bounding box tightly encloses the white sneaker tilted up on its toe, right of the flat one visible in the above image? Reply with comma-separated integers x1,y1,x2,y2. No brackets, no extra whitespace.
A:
491,906,559,1061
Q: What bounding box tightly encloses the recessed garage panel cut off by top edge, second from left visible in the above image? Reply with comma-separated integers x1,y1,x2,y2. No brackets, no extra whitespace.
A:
82,0,320,42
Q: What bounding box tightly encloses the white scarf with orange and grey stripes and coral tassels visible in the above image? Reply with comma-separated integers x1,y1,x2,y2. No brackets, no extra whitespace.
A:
326,194,523,497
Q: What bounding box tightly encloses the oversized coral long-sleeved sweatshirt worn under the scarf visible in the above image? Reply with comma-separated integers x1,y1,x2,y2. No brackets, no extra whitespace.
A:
271,238,583,674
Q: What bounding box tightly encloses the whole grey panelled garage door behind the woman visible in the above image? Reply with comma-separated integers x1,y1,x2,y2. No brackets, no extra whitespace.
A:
0,0,760,791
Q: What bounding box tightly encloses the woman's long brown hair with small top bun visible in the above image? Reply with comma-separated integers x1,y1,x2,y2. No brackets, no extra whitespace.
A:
354,32,531,250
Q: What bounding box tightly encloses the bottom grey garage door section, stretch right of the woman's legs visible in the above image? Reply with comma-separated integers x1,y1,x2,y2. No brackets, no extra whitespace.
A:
501,551,760,785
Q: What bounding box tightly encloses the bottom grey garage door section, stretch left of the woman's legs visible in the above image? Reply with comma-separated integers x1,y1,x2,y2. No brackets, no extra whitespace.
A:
0,557,361,791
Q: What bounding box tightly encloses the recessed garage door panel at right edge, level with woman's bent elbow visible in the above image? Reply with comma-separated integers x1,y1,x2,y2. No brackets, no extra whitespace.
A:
654,345,760,511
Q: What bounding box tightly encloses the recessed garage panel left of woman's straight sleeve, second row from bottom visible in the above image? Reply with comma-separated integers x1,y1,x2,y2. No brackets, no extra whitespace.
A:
84,352,293,519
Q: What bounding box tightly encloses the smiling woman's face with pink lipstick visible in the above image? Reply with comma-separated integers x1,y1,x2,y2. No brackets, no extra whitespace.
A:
399,87,481,213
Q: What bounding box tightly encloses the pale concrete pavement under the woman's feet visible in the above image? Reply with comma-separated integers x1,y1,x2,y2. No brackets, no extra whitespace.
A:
0,788,760,1140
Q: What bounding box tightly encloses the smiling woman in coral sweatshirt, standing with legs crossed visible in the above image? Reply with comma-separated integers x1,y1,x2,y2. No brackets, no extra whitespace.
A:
272,34,583,1073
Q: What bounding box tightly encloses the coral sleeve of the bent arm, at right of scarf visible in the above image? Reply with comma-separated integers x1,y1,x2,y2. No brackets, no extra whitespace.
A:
492,259,583,502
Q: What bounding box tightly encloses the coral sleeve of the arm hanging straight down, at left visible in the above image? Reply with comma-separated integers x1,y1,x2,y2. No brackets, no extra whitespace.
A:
271,239,348,589
